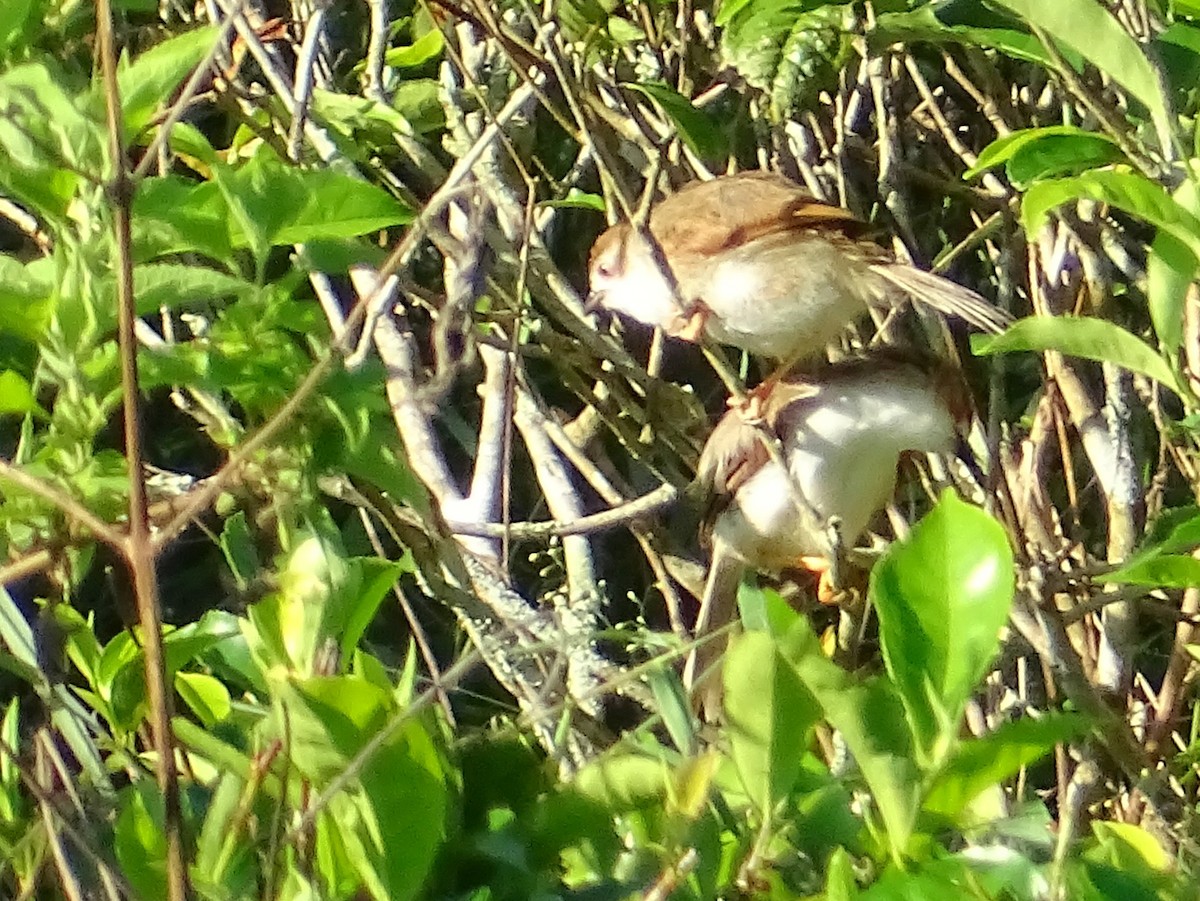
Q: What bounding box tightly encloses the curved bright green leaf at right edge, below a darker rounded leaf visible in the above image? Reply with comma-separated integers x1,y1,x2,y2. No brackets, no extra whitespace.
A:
1021,169,1200,271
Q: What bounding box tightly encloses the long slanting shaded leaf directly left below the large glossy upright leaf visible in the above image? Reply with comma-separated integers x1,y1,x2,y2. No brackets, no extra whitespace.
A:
779,617,920,858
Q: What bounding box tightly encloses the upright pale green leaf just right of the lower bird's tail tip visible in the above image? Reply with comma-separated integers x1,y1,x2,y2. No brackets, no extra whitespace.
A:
722,632,820,812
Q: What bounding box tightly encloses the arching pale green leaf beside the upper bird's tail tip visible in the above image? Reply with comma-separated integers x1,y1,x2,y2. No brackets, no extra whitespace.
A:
971,316,1178,391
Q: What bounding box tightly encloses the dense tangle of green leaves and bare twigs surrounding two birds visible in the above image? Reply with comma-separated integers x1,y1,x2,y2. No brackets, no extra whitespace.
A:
0,0,1200,900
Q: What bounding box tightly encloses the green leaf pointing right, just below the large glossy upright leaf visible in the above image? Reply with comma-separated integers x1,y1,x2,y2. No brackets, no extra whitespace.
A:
924,714,1091,818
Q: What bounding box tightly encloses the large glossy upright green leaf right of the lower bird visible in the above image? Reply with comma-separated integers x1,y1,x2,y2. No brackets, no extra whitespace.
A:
870,491,1014,762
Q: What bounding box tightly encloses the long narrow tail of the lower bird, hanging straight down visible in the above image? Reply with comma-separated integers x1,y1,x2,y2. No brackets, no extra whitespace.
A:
683,541,745,722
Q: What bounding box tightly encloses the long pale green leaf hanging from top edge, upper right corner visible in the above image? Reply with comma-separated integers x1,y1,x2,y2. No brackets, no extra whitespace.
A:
995,0,1171,142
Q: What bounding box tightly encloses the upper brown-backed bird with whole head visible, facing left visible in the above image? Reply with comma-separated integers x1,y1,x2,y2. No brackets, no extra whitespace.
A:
587,172,1012,374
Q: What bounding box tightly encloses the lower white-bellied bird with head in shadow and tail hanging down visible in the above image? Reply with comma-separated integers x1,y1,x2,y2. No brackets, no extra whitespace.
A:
684,347,972,719
